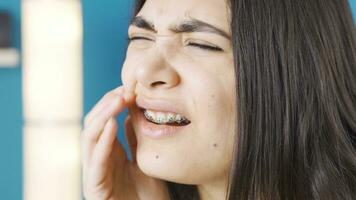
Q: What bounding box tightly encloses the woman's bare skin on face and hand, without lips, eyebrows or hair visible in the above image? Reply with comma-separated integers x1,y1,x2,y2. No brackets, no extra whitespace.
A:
82,0,236,200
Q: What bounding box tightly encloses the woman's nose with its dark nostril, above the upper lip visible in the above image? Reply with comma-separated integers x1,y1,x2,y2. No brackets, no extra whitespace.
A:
136,51,180,90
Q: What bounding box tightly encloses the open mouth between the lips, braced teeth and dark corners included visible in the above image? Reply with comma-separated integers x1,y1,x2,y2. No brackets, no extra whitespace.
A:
138,107,191,126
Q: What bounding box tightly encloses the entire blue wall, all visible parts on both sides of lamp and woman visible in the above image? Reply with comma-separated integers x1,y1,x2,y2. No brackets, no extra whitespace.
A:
0,0,356,200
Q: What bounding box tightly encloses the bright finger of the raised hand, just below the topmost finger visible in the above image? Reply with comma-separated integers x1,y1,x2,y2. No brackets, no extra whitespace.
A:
82,97,125,166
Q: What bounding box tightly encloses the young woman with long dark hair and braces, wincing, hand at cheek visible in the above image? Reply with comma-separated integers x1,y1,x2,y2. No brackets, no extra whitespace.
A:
82,0,356,200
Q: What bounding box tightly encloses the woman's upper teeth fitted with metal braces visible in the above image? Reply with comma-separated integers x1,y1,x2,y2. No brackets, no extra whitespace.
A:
144,110,186,124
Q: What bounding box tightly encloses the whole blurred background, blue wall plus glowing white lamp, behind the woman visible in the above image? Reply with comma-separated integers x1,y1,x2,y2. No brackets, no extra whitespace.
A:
0,0,356,200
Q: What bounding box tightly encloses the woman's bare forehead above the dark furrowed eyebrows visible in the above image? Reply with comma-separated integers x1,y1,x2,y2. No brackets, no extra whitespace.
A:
138,0,230,32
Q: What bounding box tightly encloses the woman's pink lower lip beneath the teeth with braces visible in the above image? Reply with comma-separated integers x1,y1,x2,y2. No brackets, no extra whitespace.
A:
138,110,188,139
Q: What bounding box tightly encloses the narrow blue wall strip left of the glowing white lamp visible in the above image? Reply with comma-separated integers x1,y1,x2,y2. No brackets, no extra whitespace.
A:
0,0,22,200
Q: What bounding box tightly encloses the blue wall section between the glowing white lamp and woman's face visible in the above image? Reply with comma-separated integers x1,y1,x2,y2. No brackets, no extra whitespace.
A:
83,0,133,159
